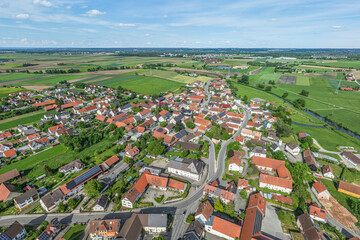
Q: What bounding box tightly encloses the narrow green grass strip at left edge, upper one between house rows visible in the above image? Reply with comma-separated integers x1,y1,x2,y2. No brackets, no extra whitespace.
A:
0,110,50,131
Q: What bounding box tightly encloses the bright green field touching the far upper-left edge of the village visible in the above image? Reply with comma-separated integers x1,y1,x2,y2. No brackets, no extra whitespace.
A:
94,75,184,95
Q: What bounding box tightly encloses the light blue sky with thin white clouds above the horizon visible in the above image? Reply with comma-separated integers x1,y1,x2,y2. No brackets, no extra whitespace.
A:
0,0,360,48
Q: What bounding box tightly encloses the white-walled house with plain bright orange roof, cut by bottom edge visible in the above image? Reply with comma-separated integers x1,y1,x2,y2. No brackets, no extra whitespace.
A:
205,215,241,240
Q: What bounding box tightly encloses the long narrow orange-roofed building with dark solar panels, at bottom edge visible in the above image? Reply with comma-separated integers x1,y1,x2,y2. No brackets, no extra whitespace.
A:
239,193,266,240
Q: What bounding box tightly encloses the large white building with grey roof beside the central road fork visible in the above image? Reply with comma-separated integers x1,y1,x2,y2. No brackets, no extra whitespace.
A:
168,158,204,181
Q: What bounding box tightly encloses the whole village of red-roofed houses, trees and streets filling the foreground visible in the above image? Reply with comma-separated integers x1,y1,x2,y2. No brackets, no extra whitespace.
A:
0,78,360,240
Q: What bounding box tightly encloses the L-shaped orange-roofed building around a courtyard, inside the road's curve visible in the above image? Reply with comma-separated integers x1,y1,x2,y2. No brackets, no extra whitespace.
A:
121,170,187,208
